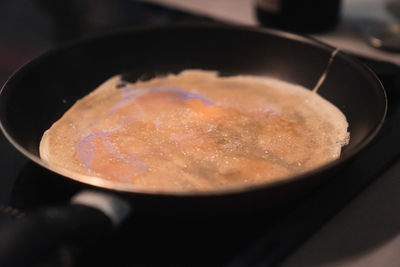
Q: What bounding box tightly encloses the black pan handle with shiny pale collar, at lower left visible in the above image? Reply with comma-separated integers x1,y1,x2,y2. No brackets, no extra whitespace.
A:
0,191,131,267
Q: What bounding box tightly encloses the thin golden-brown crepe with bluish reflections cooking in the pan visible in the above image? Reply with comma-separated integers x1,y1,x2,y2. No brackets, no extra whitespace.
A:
40,70,349,193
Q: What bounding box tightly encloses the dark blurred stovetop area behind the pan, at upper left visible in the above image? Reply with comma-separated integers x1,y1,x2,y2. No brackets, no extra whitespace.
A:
0,0,216,85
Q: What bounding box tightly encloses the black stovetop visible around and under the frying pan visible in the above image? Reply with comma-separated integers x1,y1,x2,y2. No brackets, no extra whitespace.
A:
0,0,400,267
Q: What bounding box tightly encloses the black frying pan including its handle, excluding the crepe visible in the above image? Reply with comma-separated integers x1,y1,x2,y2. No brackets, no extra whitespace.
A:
0,25,387,266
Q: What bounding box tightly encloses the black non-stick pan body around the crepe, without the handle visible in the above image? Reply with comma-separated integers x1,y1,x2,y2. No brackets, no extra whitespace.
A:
0,25,386,214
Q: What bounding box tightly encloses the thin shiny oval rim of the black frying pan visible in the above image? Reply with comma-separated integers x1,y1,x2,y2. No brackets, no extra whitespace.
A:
0,23,388,197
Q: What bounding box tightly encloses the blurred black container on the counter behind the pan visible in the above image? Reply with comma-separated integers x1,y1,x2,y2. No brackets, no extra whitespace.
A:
255,0,340,33
